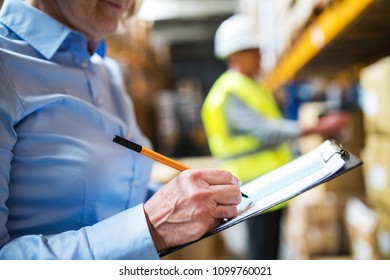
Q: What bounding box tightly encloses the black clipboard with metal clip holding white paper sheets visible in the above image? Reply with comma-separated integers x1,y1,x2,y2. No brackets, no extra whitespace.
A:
159,140,363,257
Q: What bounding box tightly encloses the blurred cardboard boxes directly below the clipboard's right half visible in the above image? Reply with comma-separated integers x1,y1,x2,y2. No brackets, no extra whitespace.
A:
283,185,358,259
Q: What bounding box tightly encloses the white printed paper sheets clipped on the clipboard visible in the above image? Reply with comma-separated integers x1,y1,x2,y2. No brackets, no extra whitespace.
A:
215,140,345,231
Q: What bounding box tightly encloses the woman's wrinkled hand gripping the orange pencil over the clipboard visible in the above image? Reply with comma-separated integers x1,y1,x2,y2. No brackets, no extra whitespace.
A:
144,169,241,251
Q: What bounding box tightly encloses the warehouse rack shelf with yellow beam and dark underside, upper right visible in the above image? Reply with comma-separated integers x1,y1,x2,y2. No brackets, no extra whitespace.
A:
266,0,390,90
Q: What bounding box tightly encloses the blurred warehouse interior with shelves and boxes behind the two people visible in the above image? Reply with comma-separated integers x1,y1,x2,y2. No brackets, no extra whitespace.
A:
0,0,390,259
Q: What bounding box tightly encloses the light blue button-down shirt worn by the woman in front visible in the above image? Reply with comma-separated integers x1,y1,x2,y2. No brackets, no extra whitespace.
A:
0,0,158,259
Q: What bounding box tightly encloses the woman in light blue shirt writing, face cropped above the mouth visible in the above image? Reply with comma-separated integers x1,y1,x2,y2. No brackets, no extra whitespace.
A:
0,0,241,259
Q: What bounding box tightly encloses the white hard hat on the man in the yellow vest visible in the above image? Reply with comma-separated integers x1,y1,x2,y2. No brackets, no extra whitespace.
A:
214,14,260,59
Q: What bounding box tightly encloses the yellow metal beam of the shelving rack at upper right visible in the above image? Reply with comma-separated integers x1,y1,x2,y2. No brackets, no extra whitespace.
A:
265,0,378,90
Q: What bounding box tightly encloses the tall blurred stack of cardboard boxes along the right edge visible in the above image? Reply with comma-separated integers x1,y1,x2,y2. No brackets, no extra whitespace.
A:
360,57,390,259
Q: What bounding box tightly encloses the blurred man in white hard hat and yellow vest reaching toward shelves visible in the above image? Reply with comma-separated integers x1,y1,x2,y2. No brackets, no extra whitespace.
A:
201,14,349,259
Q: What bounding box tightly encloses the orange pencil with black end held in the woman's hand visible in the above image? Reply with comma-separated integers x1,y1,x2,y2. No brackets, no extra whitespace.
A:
113,135,248,198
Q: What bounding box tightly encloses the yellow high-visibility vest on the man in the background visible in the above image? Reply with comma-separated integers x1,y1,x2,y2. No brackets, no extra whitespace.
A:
201,71,293,182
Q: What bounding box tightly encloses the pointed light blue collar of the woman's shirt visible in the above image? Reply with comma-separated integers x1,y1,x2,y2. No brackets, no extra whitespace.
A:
0,0,71,59
